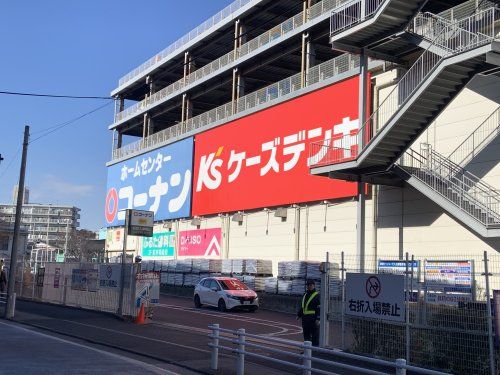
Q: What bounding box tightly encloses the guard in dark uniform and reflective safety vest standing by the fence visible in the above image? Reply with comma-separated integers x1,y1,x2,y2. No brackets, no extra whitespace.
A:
297,280,320,346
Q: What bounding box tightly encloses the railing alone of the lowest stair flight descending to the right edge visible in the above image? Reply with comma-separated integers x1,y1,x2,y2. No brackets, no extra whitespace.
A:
399,145,500,226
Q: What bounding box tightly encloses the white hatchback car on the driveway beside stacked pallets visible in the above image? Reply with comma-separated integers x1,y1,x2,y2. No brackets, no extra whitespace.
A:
194,277,259,311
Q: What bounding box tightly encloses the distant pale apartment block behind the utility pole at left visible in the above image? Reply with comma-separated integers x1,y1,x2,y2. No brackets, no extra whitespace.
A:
0,187,80,250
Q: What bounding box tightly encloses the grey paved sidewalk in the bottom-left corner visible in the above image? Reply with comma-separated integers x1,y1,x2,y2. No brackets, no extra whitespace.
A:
0,320,185,375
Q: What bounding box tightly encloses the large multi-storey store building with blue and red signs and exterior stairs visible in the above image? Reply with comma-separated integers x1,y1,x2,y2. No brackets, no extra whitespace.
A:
105,0,500,271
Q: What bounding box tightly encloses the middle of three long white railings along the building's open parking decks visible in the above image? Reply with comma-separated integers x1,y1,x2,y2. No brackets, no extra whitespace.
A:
115,0,354,122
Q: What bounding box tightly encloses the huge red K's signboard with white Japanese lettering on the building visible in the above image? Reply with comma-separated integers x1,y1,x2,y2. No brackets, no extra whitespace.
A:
192,77,366,215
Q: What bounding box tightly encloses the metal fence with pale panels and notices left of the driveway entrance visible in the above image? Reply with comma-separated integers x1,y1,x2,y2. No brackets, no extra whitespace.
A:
11,263,138,316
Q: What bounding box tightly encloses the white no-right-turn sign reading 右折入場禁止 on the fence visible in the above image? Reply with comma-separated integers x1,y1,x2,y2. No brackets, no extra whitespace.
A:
345,273,406,322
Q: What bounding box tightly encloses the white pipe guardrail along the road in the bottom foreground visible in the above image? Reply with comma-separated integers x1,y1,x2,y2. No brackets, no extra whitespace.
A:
208,324,446,375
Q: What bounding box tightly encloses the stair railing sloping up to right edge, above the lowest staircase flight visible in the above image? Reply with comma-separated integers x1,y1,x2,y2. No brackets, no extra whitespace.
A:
448,107,500,167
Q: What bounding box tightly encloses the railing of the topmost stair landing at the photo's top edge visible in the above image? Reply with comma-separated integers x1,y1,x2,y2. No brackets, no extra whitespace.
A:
330,0,386,35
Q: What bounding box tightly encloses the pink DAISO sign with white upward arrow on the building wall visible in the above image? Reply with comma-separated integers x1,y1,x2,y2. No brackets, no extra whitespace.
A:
177,228,222,258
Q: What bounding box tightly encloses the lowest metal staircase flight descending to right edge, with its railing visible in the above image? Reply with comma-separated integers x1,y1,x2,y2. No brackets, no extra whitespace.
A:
392,144,500,237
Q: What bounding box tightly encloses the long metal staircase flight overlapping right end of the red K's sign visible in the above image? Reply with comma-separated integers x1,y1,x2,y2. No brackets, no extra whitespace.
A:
310,8,500,182
